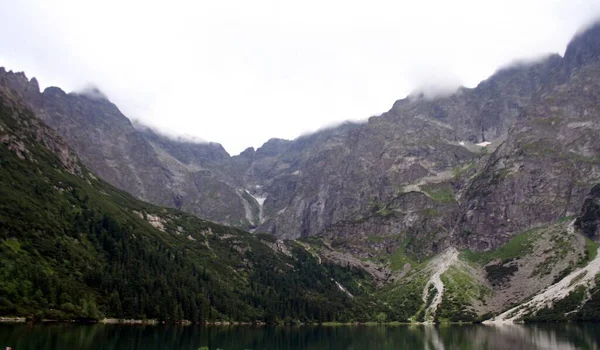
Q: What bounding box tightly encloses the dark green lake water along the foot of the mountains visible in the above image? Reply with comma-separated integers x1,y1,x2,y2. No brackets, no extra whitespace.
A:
0,324,600,350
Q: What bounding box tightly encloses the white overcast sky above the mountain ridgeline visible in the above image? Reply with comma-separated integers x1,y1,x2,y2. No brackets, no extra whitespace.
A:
0,0,600,154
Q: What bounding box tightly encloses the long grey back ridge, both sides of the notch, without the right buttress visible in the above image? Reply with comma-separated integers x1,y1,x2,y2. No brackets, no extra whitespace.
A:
0,24,600,246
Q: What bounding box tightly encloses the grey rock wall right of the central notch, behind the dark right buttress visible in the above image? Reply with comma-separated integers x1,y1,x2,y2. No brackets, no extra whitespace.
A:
243,52,563,241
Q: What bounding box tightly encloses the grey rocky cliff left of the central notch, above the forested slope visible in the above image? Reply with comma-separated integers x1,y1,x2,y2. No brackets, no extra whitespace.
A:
0,69,255,227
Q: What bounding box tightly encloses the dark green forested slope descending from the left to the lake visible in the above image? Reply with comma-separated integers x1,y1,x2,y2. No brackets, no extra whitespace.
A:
0,92,382,323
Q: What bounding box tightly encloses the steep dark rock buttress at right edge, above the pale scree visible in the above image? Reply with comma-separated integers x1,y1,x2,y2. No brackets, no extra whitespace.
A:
455,55,600,250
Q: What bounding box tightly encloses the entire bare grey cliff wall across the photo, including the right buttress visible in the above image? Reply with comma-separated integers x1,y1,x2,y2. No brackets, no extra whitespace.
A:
0,21,600,255
